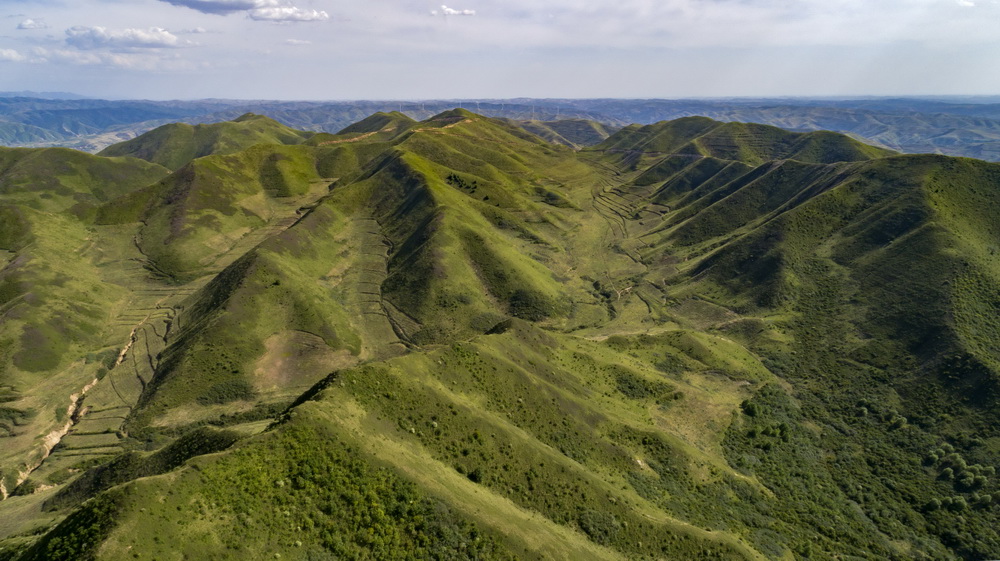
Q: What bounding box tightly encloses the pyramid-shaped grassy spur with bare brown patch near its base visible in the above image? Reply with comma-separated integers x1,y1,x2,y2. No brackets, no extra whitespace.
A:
128,200,368,431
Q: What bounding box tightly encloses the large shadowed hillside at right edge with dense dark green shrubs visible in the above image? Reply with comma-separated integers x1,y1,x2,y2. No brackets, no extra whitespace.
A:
632,149,1000,558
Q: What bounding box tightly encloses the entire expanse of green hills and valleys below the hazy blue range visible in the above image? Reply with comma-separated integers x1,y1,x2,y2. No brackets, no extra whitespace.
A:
0,109,1000,560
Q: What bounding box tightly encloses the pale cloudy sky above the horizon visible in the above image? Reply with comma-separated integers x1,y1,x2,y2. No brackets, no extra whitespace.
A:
0,0,1000,100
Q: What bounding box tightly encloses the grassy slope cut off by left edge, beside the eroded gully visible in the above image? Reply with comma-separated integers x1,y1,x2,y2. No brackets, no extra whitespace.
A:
0,206,129,495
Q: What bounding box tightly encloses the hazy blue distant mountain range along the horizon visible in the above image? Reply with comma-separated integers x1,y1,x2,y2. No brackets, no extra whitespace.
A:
0,95,1000,161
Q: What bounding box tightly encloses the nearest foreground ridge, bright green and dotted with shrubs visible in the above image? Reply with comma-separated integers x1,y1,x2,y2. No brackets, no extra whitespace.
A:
21,320,804,559
